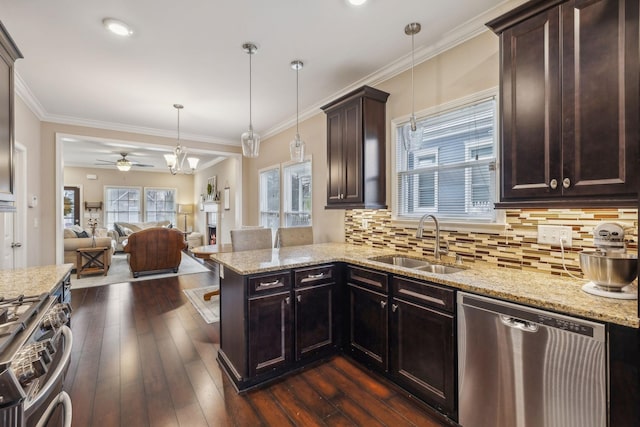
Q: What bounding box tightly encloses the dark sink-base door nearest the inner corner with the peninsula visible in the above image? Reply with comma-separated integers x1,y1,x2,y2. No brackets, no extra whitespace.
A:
348,284,388,371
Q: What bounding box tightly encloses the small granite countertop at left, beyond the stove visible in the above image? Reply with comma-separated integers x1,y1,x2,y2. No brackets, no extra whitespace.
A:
0,264,73,298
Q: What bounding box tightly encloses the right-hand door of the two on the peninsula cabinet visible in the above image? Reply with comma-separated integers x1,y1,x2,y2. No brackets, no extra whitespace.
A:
295,283,334,360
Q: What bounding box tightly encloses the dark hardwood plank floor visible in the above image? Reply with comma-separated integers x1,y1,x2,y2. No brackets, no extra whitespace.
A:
65,273,445,427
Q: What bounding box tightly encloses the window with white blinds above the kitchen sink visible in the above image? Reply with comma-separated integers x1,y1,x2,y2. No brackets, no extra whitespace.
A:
394,98,496,222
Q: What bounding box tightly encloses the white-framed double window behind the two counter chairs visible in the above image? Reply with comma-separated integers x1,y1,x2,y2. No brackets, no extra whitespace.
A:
260,160,311,230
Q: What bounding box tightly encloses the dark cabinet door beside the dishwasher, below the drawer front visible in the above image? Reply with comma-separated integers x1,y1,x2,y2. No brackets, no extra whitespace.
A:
390,299,456,418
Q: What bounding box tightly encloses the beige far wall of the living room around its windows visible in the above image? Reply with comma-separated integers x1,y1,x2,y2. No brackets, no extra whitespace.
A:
64,167,197,229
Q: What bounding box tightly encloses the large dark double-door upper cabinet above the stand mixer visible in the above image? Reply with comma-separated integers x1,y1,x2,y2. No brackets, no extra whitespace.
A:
487,0,640,207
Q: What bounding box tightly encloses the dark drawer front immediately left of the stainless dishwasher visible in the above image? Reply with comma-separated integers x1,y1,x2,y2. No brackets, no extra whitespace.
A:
392,277,455,313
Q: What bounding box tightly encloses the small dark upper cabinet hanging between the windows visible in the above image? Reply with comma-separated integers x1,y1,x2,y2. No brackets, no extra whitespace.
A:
322,86,389,209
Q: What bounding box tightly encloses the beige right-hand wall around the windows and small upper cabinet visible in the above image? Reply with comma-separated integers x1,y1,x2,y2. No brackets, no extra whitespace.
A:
243,31,499,242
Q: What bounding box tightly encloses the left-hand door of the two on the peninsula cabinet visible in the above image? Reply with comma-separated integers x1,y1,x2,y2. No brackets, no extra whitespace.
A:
249,292,292,376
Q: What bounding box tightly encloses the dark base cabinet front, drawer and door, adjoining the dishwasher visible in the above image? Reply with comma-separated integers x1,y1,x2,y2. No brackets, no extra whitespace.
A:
389,277,457,419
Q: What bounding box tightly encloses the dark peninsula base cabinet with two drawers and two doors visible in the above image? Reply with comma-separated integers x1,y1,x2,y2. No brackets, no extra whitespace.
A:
218,264,338,390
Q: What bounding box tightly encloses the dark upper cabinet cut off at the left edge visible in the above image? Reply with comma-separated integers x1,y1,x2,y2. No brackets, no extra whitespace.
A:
0,22,22,212
